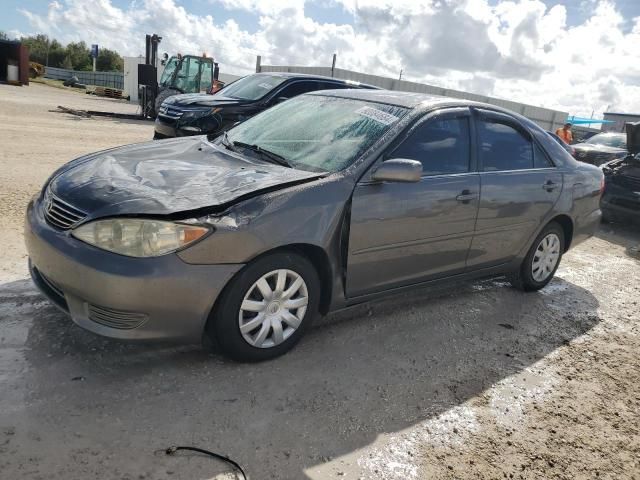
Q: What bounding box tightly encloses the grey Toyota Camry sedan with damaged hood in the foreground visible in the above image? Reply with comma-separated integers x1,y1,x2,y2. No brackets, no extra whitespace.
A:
25,90,603,360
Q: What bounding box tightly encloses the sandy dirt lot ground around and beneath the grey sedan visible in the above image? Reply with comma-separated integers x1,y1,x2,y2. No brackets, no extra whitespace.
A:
0,85,640,480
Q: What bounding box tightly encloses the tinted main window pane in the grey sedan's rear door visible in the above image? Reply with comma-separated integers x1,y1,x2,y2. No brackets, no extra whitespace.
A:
478,120,533,172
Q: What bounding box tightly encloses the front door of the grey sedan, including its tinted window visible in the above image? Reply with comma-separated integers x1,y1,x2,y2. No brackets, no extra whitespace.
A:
346,108,480,297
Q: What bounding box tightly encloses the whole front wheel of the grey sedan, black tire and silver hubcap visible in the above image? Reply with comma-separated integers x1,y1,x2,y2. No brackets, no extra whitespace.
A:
206,252,320,362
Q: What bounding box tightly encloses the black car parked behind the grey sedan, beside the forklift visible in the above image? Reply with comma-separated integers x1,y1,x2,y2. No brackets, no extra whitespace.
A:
153,73,377,139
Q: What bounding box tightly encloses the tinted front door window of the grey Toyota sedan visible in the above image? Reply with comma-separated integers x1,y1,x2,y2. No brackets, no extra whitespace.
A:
392,118,469,175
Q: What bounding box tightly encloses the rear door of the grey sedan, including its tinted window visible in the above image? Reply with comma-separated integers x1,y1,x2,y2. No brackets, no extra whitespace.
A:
467,109,563,269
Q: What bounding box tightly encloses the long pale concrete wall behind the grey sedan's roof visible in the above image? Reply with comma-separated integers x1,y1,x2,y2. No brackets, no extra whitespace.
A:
260,65,568,130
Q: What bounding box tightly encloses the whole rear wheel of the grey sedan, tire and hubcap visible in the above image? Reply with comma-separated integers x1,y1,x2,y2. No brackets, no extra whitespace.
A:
507,222,565,292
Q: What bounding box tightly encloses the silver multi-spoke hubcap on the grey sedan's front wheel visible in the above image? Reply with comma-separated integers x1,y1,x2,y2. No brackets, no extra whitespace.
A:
238,269,309,348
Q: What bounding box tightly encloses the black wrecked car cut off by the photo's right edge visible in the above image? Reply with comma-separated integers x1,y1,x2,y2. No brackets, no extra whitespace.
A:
601,123,640,222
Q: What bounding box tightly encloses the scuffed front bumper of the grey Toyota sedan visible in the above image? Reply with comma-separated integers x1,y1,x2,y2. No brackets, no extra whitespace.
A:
25,197,242,342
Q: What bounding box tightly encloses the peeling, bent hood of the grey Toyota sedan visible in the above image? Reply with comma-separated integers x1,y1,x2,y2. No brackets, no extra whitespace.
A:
48,137,322,219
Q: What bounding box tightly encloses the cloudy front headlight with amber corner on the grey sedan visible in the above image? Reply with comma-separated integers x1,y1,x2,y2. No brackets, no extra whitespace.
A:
71,218,210,257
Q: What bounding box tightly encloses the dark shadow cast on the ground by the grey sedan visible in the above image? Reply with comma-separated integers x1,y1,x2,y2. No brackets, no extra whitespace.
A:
0,279,599,479
